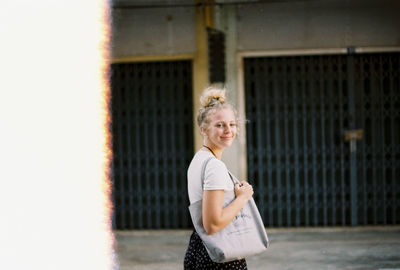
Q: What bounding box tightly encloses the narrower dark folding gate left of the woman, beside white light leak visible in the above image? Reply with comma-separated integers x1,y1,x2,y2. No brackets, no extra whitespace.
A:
111,61,193,230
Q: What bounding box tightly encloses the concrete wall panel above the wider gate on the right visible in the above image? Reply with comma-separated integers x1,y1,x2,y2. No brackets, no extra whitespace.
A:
237,0,400,51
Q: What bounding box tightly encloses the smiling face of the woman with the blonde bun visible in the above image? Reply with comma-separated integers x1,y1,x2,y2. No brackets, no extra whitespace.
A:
203,108,237,149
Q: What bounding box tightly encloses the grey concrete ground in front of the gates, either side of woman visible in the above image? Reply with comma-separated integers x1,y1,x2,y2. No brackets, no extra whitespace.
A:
116,226,400,270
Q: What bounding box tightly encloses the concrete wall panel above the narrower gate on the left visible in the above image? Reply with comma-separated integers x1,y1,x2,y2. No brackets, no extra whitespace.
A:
112,7,196,59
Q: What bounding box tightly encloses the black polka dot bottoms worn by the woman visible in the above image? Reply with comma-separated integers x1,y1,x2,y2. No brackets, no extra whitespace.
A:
183,231,247,270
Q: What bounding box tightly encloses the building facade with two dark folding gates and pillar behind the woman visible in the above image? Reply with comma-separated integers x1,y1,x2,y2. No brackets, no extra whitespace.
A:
111,0,400,229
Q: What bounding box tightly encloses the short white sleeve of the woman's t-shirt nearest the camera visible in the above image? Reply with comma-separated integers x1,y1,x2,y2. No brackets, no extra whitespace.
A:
204,158,233,190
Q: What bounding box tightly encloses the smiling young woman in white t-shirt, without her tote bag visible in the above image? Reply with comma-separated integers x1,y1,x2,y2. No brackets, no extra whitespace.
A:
184,88,253,270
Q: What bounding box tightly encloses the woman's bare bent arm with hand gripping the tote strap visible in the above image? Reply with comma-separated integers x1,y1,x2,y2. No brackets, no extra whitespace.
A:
203,182,253,234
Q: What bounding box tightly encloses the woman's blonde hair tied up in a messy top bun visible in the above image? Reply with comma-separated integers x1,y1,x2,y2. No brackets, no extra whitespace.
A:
197,86,237,127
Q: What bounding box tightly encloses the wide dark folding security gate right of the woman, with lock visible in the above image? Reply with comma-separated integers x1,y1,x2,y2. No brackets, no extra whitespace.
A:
244,53,400,227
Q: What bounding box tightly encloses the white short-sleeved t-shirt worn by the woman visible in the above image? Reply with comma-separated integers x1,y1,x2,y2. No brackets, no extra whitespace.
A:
187,150,234,203
